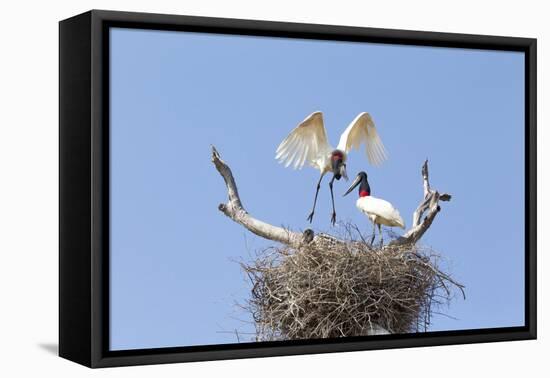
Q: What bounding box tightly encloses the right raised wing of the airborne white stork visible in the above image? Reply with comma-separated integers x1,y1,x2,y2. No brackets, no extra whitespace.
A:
338,113,388,165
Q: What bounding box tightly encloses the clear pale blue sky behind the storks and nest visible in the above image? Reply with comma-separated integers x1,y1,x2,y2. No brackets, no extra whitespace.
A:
110,29,524,350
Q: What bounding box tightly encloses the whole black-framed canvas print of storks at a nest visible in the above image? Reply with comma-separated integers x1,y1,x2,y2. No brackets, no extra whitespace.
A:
59,10,536,367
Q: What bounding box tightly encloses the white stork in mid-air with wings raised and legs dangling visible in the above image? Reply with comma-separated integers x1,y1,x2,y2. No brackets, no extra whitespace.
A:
275,112,387,224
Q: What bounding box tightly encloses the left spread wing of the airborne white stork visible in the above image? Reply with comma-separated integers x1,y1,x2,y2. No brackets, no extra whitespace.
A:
275,112,330,169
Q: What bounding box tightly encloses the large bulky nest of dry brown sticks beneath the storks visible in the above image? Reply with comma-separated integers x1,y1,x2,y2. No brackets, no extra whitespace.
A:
241,226,464,341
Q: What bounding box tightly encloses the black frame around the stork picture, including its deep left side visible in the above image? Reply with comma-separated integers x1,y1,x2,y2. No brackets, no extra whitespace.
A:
59,10,537,368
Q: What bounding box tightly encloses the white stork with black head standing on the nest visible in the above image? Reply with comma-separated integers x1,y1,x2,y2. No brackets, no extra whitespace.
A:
344,172,405,245
